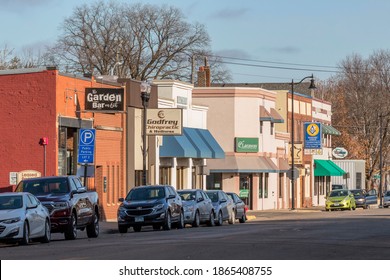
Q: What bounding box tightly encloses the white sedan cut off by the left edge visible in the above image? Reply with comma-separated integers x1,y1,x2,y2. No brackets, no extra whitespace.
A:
0,192,51,245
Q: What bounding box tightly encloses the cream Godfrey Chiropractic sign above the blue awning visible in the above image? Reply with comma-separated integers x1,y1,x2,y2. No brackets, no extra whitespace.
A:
146,108,183,135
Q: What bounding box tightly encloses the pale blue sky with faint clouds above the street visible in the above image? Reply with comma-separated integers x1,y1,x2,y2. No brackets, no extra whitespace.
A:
0,0,390,83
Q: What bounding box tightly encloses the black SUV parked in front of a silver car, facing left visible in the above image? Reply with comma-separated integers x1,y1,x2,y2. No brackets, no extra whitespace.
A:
118,185,184,233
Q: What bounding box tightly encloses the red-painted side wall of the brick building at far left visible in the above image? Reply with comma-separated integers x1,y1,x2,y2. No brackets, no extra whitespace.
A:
0,71,57,188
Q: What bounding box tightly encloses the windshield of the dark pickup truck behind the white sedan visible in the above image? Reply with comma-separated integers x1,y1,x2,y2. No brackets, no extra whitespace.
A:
16,178,69,195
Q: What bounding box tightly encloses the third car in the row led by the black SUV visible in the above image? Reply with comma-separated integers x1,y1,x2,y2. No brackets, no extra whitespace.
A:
206,190,236,226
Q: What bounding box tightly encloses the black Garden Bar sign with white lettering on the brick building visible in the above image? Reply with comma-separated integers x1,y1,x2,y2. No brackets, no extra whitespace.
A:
85,88,124,112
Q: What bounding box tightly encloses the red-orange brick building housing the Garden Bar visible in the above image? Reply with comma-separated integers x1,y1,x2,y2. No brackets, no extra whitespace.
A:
0,68,126,219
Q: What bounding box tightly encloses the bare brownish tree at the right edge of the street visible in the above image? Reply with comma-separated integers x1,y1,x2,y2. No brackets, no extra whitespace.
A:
323,50,390,188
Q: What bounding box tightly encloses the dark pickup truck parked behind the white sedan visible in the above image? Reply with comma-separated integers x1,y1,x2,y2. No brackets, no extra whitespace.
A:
16,176,100,240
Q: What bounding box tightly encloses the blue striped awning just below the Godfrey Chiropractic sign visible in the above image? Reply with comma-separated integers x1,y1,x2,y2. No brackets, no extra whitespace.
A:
160,127,225,158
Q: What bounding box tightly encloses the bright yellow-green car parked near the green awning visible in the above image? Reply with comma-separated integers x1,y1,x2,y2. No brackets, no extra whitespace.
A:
325,189,356,211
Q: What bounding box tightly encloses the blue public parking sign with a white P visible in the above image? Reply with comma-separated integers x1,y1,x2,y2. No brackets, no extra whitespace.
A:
77,129,96,164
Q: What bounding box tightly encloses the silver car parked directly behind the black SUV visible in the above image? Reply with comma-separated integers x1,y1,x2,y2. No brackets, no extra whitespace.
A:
177,189,215,227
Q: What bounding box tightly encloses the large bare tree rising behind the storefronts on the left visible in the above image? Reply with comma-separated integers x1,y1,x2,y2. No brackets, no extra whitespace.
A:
47,1,232,80
